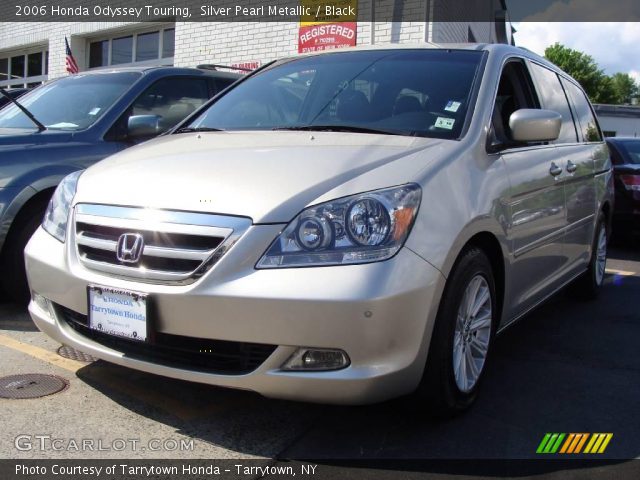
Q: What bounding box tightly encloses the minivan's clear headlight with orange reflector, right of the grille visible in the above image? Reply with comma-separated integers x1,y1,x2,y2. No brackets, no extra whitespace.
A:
256,184,422,268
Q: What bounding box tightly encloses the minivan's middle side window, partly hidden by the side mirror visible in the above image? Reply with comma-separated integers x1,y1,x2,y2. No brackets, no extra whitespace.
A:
531,63,577,143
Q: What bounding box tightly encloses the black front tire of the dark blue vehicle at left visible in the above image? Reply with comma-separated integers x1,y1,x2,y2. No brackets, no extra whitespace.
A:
0,201,47,305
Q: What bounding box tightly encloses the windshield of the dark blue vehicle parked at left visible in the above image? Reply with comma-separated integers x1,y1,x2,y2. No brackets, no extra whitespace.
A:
0,72,141,130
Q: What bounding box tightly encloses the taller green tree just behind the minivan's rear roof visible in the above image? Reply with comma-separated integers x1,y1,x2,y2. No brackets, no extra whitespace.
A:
544,43,614,103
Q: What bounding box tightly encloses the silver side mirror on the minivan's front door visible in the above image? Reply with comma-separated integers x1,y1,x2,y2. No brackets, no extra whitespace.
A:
509,108,562,142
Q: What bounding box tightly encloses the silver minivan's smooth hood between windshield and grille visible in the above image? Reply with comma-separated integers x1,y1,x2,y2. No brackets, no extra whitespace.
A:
74,131,444,223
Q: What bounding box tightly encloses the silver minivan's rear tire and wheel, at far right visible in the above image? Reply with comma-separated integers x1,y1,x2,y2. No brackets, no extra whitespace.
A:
570,214,609,300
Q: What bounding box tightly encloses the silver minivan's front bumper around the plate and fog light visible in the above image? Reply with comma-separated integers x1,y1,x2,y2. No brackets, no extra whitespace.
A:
25,225,444,404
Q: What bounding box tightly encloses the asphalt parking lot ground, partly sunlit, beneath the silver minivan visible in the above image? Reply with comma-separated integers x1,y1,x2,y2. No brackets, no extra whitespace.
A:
0,245,640,476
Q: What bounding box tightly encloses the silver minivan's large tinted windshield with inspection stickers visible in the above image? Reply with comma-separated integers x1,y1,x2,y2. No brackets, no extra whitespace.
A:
188,49,482,139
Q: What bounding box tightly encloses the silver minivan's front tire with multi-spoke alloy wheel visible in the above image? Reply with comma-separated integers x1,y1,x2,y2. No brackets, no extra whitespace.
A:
415,247,498,417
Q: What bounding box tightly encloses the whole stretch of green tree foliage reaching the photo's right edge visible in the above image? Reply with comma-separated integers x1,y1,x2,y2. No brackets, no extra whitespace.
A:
544,43,638,104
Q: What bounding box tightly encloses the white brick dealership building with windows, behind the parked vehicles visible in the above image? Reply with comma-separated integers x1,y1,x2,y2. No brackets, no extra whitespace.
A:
0,0,512,88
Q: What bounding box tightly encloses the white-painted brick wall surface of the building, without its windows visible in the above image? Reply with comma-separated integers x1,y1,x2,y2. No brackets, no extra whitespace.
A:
0,16,495,78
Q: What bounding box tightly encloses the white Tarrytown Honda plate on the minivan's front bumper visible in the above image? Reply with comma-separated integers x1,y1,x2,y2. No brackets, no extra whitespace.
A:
88,286,147,342
